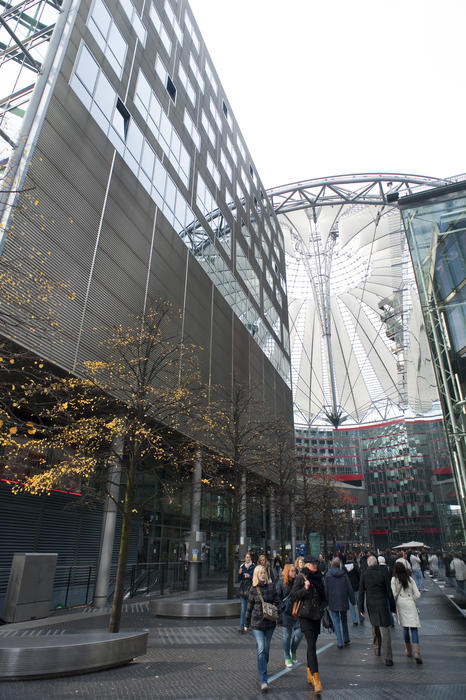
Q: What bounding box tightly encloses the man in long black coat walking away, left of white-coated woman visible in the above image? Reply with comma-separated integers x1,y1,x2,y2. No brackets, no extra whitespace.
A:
359,555,396,666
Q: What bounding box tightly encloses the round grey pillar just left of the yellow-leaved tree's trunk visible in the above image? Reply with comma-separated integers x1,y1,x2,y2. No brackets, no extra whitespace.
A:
94,438,123,608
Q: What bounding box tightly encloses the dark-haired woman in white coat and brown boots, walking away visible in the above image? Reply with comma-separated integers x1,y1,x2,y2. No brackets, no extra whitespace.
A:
391,562,422,664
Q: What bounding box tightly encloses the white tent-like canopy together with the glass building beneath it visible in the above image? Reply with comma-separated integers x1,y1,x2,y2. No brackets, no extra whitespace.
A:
269,173,464,546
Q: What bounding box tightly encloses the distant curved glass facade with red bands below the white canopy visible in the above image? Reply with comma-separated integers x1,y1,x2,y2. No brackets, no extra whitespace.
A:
295,418,461,548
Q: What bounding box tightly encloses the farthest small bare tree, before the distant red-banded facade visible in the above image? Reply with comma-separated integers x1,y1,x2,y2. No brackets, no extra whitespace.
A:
302,468,352,556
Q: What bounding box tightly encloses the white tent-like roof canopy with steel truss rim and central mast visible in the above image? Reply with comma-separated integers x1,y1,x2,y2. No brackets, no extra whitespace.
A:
267,173,451,426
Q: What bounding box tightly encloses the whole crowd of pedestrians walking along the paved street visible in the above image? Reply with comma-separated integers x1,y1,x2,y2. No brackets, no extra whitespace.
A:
238,550,466,692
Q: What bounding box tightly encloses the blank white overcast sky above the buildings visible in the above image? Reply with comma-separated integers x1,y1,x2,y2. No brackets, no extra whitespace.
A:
190,0,466,187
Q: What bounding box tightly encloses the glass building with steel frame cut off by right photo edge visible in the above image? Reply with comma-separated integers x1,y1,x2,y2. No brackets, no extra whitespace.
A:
399,181,466,538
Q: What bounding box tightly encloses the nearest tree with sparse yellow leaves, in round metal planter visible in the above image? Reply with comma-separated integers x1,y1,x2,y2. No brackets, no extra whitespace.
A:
0,302,206,632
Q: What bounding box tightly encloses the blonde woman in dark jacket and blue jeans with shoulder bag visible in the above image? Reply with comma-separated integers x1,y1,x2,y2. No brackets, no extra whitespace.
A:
244,564,280,693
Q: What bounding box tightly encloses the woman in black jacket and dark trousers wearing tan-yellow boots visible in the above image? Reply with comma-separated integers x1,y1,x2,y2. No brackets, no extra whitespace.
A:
291,557,327,693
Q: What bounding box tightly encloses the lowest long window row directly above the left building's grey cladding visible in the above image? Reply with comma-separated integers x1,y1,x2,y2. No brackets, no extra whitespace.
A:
70,43,290,385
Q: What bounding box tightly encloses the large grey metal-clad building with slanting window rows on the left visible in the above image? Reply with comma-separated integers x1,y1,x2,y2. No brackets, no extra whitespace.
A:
0,0,292,600
